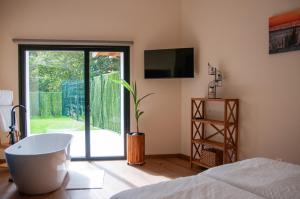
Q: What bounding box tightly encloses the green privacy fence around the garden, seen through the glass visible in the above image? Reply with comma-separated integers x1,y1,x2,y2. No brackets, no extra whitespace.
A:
30,72,121,133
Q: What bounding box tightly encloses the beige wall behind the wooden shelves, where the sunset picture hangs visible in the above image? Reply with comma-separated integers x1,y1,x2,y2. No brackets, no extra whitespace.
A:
181,0,300,164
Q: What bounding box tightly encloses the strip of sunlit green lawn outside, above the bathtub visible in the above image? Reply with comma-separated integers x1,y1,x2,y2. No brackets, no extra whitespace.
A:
30,117,85,134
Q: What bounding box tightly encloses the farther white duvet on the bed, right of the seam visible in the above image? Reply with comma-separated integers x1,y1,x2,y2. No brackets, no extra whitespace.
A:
203,158,300,199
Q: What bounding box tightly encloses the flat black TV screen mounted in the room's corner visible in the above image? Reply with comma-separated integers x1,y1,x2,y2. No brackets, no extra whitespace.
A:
144,48,194,79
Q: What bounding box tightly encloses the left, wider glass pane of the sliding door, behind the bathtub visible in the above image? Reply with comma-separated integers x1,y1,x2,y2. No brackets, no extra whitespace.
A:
25,50,86,157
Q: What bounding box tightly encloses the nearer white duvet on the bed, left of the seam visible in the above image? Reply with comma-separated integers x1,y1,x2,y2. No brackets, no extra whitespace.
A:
112,175,262,199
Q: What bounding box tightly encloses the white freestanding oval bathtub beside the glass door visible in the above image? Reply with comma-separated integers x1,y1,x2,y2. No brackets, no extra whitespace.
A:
5,133,73,194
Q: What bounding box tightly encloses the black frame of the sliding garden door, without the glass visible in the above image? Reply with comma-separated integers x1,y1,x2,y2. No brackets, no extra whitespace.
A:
18,44,130,161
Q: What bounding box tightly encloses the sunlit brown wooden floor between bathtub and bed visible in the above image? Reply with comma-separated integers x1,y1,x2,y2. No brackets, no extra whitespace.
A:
0,158,200,199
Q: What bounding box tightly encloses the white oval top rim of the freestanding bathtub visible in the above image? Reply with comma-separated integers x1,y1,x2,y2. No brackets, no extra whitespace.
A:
4,133,74,157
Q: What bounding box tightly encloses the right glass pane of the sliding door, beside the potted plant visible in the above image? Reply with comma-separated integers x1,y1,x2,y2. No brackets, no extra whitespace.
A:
89,51,125,157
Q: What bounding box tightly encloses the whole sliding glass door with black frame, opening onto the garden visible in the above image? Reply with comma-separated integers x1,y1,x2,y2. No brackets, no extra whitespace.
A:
19,45,129,159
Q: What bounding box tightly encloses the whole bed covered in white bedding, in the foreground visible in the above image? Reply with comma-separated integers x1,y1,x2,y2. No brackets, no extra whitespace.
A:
112,158,300,199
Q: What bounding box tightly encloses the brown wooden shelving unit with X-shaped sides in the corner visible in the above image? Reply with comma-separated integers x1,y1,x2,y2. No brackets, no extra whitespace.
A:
190,98,239,168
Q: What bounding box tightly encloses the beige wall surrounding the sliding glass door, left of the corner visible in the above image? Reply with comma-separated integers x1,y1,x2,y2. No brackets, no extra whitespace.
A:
0,0,180,154
